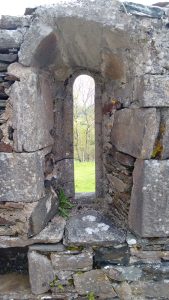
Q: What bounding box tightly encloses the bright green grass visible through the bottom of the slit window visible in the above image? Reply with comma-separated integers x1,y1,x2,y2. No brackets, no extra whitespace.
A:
74,161,95,193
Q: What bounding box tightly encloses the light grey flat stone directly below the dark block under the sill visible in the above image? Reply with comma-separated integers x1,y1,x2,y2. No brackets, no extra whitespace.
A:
103,266,142,281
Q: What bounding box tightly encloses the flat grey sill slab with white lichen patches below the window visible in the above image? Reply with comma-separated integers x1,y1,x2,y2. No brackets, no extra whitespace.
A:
64,210,125,245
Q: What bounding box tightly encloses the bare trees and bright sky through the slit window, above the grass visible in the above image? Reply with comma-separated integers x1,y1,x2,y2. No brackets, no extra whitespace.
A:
73,75,95,161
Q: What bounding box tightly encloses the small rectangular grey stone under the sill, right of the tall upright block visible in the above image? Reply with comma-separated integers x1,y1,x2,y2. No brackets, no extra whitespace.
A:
51,251,93,271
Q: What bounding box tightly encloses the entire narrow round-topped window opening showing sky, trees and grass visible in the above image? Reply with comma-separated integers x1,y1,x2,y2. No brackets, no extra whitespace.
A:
73,75,96,197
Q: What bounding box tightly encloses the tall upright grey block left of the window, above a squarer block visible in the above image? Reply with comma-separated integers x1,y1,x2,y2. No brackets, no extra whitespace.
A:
8,63,53,152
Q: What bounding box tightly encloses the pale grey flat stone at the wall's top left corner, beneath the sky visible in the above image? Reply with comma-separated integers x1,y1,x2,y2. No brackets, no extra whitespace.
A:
0,16,31,30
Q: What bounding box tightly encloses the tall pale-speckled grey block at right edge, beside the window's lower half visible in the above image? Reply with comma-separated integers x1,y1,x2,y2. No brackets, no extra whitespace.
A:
129,159,169,237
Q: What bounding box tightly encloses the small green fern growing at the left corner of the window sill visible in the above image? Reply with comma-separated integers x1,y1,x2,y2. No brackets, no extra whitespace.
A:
58,189,74,218
